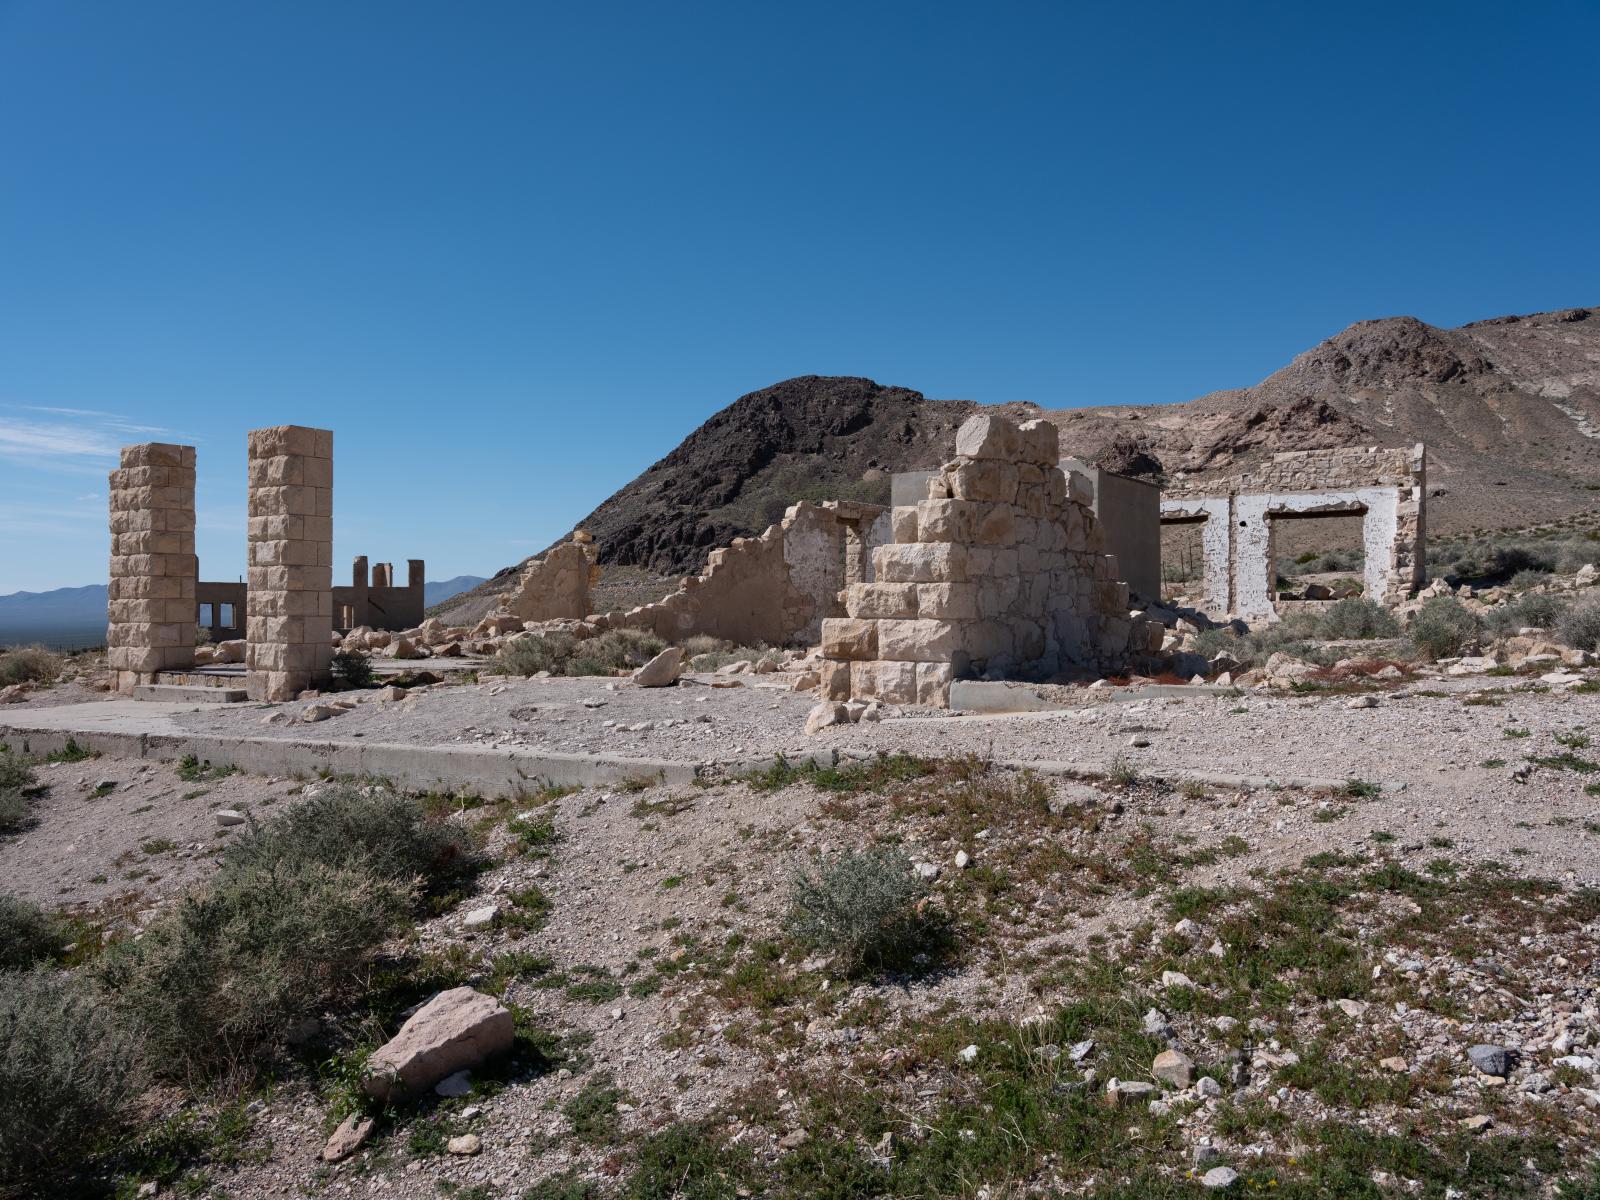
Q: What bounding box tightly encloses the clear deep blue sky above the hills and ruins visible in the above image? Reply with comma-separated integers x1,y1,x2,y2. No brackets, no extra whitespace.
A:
0,0,1600,592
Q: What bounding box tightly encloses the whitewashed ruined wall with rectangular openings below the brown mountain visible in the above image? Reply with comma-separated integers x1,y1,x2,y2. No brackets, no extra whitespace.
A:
1162,443,1427,621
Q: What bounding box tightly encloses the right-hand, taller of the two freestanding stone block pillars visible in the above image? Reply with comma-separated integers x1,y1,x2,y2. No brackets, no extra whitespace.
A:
245,426,333,701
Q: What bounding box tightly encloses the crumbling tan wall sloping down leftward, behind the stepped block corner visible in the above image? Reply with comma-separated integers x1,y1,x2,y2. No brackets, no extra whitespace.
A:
606,501,893,646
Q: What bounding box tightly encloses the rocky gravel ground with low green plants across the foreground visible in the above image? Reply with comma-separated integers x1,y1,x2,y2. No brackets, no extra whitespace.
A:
9,664,1600,1200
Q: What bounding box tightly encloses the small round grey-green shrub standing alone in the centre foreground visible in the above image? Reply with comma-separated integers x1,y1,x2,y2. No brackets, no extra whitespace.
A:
789,848,928,973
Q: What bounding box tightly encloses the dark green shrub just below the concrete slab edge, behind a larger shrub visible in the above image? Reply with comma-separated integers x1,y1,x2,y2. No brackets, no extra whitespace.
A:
222,782,482,888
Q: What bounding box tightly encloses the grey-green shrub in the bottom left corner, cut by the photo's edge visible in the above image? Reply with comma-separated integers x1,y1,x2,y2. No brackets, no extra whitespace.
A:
0,971,141,1195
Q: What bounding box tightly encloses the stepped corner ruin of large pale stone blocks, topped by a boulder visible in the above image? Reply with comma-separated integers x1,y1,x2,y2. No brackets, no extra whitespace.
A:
822,416,1158,706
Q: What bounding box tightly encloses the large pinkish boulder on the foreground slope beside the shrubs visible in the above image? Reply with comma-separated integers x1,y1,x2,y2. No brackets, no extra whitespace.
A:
363,987,515,1099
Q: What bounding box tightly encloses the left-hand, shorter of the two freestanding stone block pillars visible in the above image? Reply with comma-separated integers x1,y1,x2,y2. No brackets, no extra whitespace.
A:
106,442,200,693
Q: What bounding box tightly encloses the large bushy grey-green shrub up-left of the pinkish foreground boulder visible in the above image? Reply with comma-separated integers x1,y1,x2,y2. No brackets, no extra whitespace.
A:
96,859,414,1078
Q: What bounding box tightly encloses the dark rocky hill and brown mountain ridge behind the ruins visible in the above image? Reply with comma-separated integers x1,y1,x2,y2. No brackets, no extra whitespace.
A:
444,309,1600,620
